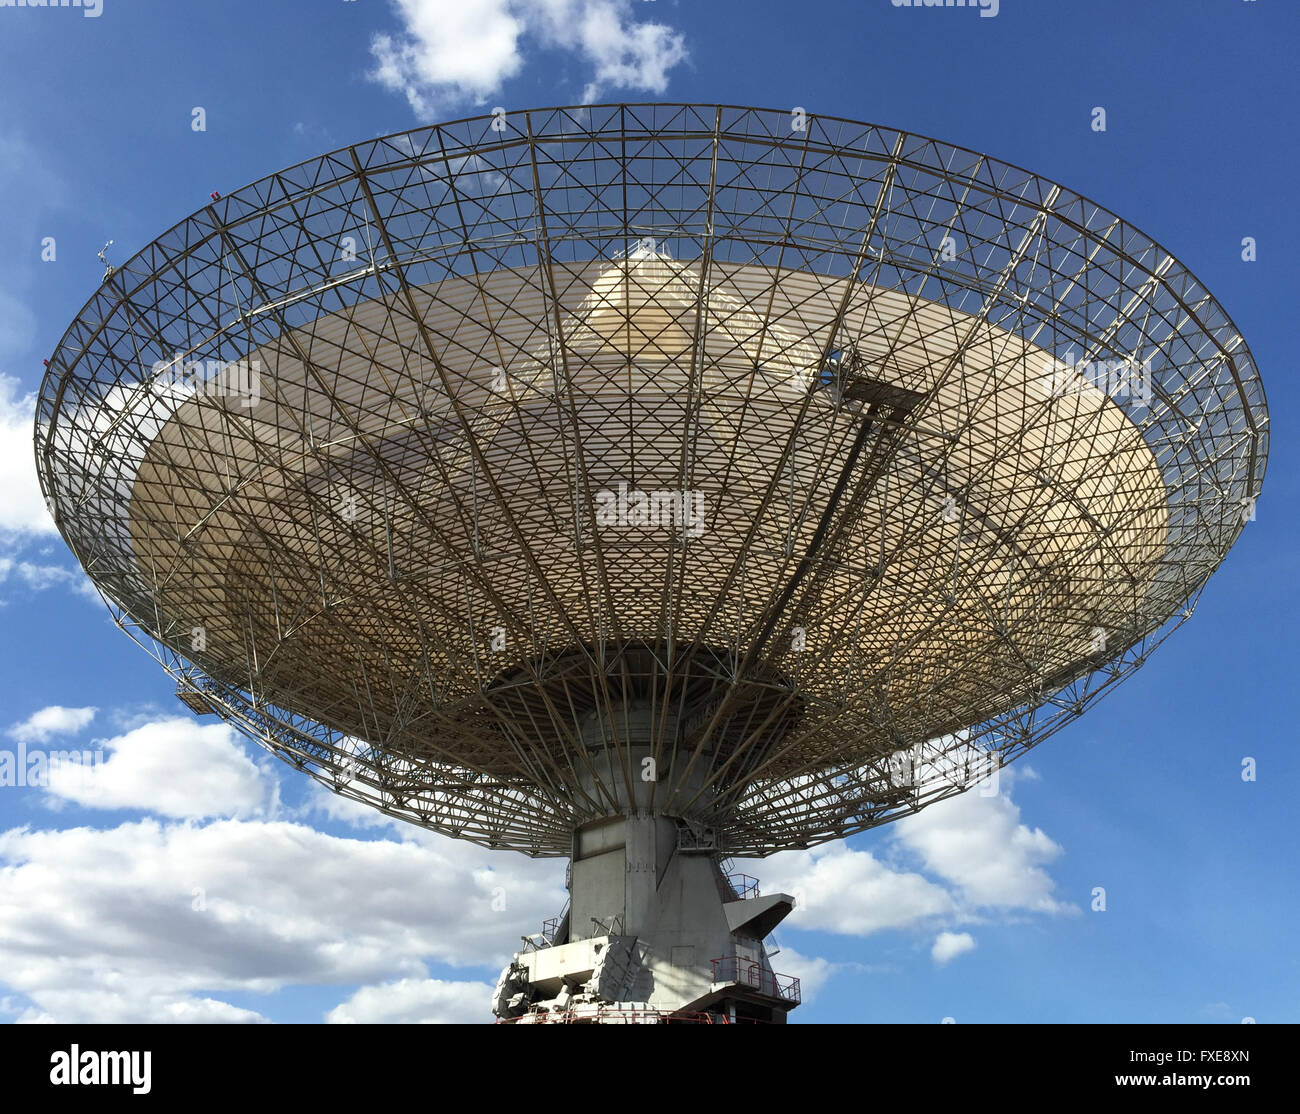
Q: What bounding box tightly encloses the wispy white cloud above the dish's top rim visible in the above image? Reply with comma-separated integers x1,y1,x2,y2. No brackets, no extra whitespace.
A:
371,0,686,118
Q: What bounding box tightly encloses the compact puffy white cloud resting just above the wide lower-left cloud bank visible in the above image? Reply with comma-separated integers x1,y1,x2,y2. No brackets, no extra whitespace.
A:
38,708,277,819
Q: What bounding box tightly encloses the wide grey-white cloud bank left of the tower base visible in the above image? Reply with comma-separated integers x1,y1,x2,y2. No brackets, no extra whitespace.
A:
0,820,564,1022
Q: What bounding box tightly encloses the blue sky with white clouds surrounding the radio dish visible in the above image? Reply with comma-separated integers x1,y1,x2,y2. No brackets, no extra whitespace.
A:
0,0,1300,1023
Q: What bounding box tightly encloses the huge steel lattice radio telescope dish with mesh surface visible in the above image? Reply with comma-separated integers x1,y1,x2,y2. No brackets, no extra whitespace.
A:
36,104,1268,855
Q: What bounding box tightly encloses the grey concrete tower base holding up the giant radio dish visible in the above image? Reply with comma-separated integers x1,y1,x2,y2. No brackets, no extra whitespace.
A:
493,815,800,1024
